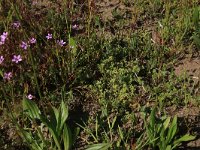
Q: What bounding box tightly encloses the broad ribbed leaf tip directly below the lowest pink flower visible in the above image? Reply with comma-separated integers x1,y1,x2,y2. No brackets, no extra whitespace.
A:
23,99,41,119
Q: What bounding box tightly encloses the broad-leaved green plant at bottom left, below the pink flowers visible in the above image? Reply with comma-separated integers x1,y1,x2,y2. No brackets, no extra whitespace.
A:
19,99,79,150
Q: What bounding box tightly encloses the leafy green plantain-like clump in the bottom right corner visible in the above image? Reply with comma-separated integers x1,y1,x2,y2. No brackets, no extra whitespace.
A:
141,108,196,150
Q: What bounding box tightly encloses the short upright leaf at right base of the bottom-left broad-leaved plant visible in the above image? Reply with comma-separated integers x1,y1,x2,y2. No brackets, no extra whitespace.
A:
63,124,73,150
